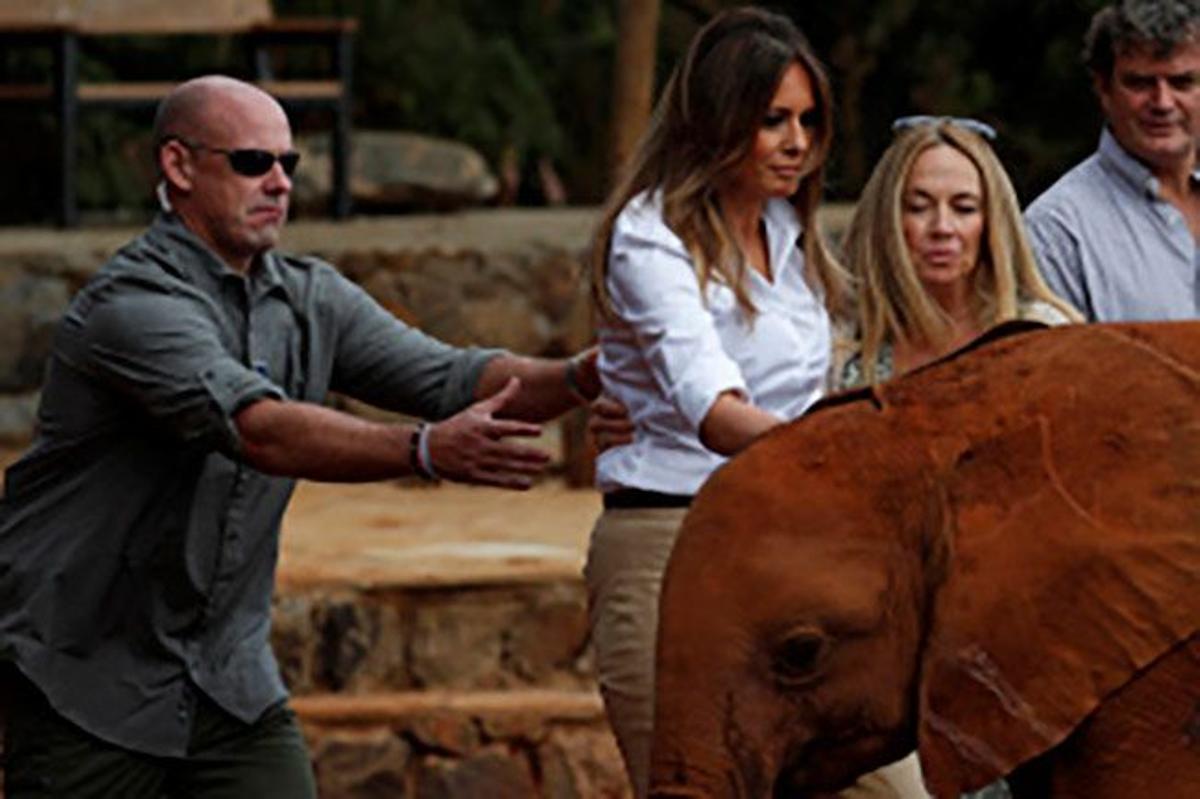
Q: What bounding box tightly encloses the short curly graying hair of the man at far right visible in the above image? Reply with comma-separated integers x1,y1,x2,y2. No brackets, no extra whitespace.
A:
1084,0,1200,80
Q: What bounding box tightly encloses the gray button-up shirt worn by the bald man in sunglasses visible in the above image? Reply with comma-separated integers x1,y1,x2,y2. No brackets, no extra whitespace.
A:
0,216,496,756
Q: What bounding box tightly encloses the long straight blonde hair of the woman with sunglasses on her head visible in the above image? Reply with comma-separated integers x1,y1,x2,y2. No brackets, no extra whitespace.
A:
844,120,1081,383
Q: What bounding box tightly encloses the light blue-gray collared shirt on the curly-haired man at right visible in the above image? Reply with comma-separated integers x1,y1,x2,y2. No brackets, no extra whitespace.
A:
1025,128,1200,322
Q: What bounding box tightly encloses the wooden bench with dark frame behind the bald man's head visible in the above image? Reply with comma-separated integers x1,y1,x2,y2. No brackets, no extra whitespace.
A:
0,0,358,227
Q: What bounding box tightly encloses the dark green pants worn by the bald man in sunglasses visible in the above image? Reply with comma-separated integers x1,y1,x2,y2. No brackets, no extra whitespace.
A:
5,678,317,799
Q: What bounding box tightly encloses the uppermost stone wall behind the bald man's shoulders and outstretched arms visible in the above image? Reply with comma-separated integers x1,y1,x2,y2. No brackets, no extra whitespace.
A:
0,209,595,445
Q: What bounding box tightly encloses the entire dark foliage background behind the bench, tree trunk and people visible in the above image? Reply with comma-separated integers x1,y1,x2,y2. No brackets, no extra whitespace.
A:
0,0,1137,221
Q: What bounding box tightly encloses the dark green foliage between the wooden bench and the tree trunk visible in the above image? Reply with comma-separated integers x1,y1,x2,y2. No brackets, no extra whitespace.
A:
276,0,614,197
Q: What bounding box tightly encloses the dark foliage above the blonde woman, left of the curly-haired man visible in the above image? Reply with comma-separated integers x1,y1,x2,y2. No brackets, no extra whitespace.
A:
790,0,1105,200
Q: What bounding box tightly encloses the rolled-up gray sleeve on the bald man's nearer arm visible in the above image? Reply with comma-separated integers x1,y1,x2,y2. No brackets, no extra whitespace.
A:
58,289,284,455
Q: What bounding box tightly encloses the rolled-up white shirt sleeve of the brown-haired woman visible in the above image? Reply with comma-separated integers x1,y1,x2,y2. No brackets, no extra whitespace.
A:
608,220,749,431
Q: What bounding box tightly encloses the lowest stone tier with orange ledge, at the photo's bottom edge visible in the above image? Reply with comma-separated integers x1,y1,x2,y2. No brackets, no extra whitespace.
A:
293,691,631,799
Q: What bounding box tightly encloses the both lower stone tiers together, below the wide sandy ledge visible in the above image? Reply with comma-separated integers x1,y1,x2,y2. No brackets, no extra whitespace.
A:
274,578,628,799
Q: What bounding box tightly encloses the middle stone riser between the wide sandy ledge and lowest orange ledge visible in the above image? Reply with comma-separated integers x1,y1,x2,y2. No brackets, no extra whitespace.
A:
271,578,595,696
